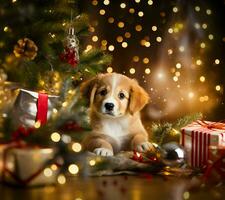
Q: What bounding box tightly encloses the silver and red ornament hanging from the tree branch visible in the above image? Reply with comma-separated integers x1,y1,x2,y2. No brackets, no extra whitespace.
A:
60,27,79,67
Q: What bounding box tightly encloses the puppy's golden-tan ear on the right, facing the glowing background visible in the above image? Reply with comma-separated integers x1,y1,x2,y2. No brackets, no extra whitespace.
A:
128,80,150,115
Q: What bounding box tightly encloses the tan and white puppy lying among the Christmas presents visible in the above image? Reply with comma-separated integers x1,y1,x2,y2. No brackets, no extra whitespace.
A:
81,73,153,156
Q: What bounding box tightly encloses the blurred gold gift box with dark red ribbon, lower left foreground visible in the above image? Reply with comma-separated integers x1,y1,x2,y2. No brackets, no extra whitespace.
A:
0,145,58,186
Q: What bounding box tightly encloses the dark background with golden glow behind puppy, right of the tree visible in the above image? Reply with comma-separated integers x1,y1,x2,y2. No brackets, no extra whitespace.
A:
80,0,225,120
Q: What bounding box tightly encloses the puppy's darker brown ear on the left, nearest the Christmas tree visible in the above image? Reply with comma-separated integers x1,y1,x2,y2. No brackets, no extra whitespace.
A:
80,77,98,105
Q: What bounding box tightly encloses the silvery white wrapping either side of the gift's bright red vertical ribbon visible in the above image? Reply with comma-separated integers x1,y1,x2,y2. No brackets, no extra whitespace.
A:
13,89,58,127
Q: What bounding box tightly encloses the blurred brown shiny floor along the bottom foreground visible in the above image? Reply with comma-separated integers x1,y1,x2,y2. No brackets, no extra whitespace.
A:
0,176,225,200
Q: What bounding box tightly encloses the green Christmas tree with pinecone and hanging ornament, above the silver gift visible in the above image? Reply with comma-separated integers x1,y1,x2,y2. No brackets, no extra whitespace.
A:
0,1,111,136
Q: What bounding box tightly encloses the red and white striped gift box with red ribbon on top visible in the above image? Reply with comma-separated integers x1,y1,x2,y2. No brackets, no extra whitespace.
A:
181,120,225,168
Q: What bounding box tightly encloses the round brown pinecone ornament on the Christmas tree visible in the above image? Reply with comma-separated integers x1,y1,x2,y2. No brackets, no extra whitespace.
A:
13,38,38,60
